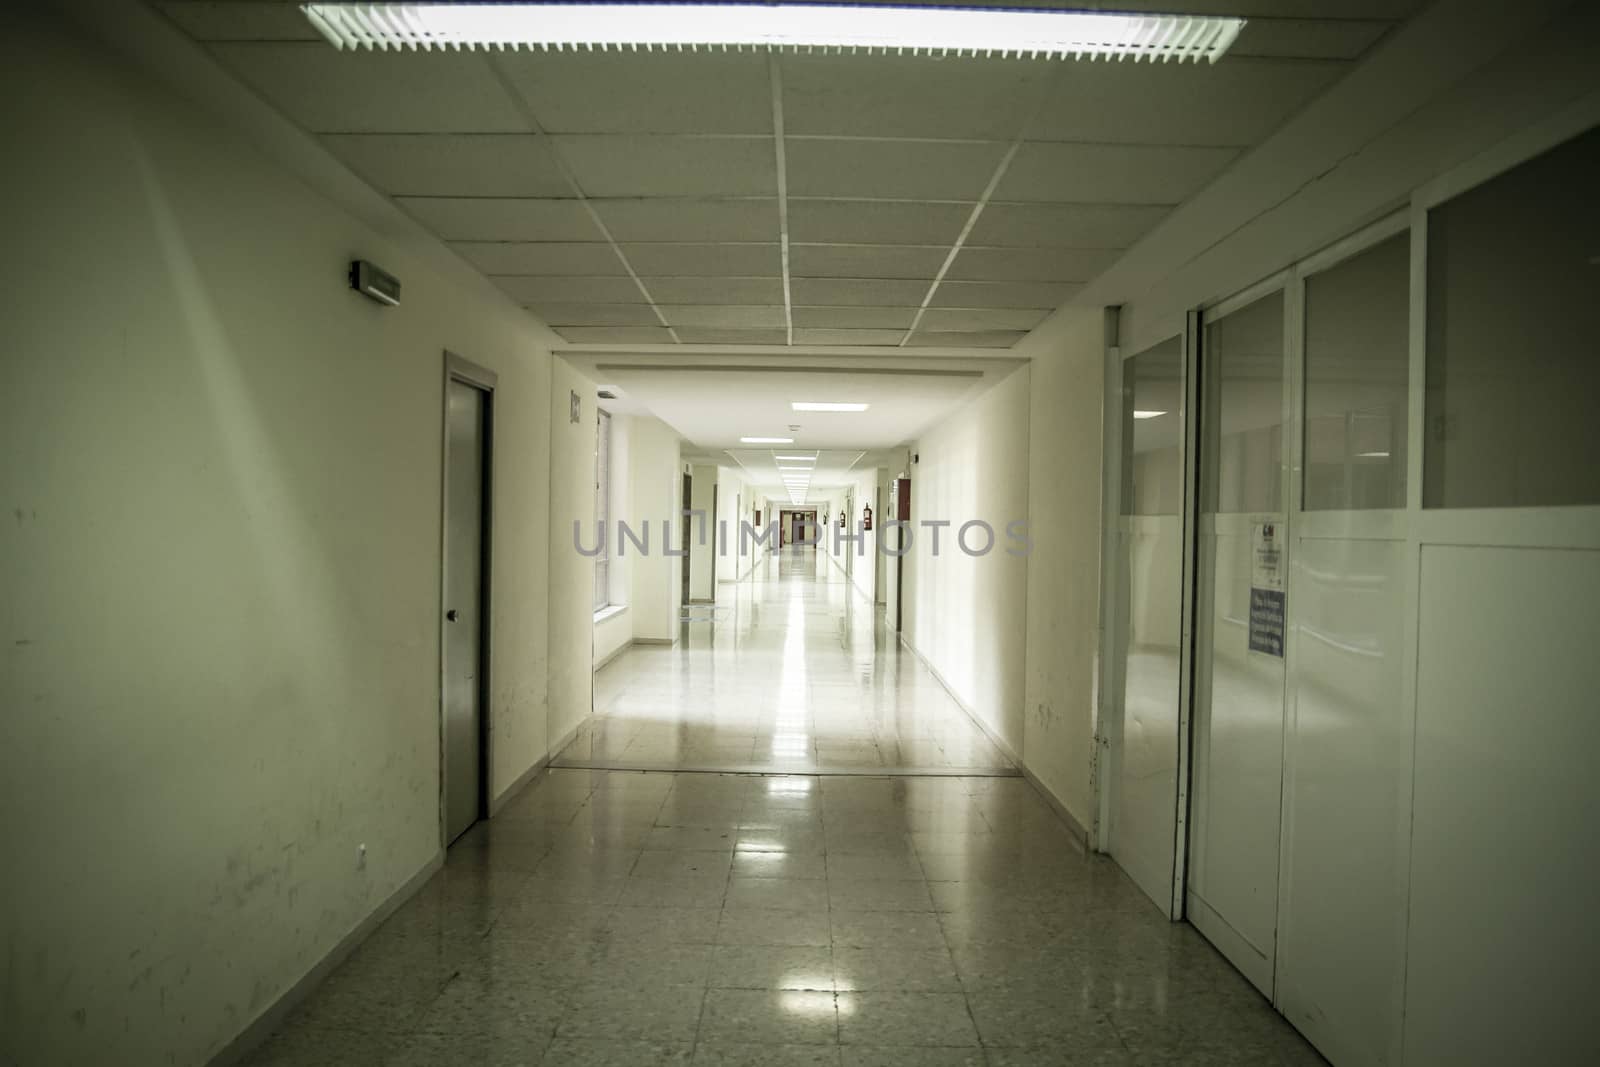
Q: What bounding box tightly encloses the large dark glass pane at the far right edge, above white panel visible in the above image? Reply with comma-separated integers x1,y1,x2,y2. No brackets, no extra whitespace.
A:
1422,130,1600,507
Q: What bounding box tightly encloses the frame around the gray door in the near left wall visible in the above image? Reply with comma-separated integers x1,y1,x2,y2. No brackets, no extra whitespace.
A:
438,349,499,849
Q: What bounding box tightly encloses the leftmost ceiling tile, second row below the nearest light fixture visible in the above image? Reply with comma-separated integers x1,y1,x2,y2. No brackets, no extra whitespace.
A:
322,133,573,197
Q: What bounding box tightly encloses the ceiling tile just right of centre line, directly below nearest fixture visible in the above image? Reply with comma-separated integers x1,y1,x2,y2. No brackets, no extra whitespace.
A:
781,56,1056,141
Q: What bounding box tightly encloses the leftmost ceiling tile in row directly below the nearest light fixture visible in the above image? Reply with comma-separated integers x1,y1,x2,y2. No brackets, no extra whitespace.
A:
211,40,528,133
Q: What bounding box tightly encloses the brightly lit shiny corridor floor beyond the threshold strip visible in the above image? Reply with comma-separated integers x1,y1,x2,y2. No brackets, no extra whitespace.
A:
555,547,1016,774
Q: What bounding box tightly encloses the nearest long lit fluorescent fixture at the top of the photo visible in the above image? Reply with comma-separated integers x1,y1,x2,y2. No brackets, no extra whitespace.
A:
301,3,1245,62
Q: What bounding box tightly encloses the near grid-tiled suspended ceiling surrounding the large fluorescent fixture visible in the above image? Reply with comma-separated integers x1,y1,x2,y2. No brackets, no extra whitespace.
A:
157,0,1419,350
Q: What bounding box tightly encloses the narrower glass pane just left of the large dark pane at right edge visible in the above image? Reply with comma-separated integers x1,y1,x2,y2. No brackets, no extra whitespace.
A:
1306,234,1411,510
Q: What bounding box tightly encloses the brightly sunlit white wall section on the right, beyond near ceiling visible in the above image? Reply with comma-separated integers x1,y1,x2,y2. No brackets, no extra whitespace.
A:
904,366,1030,752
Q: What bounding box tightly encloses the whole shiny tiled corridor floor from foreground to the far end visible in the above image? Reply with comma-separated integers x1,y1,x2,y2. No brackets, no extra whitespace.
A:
240,547,1322,1067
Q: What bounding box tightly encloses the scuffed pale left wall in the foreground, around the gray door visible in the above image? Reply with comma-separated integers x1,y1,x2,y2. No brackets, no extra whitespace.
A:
0,13,587,1064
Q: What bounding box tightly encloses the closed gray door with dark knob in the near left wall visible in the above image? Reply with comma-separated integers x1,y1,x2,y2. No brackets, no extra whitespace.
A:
445,381,486,841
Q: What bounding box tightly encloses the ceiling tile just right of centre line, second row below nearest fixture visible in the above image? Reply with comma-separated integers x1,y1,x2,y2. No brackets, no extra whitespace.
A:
784,138,1006,202
